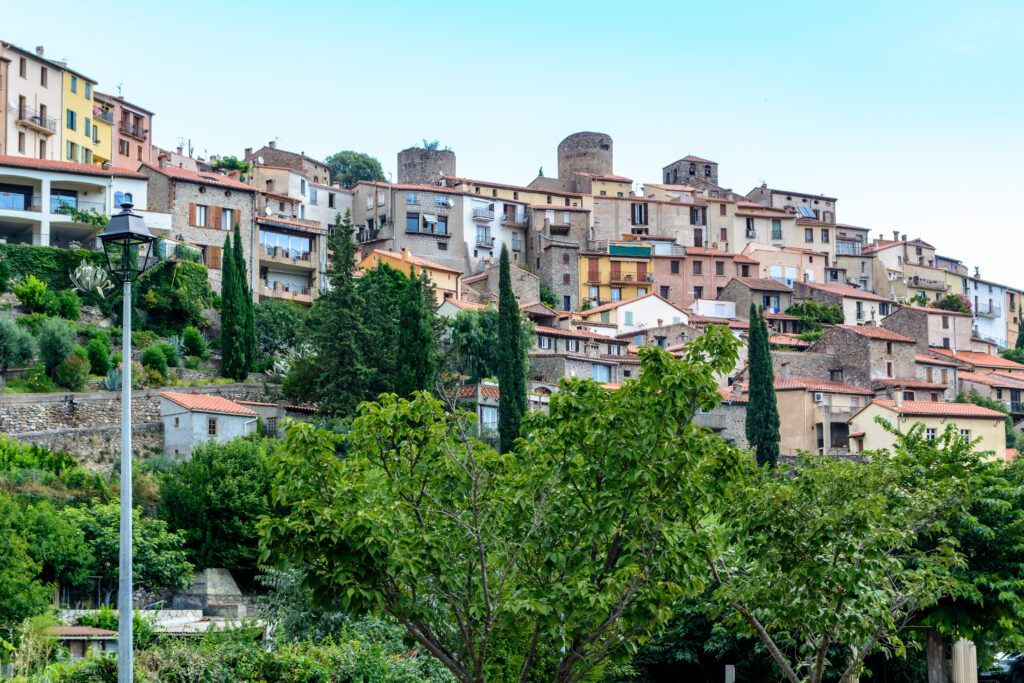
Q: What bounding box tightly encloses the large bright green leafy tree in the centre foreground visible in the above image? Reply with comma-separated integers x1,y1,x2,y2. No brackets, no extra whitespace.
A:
262,326,753,683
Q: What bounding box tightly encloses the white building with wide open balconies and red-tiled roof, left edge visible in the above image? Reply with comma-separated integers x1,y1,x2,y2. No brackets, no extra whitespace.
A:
0,156,171,249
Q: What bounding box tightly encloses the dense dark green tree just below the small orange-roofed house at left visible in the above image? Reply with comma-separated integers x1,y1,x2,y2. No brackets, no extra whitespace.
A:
158,437,278,575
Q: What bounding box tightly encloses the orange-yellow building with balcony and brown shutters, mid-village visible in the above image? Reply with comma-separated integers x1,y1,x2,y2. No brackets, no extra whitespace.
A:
579,242,654,307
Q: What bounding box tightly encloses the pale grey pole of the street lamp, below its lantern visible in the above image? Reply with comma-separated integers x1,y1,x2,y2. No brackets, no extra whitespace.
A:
118,278,135,683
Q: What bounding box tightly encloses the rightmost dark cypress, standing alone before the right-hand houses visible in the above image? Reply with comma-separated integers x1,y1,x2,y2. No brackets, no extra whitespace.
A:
745,303,779,467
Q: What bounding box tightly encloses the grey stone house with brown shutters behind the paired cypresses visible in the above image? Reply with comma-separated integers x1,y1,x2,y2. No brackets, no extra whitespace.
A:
139,163,259,292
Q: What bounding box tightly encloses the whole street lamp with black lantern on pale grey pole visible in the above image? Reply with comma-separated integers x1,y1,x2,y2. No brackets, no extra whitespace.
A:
99,203,156,683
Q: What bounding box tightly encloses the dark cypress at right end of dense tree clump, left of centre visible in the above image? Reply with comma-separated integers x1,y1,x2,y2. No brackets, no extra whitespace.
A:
395,268,437,396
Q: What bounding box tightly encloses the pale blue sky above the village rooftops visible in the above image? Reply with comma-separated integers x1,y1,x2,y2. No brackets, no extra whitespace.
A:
8,0,1024,288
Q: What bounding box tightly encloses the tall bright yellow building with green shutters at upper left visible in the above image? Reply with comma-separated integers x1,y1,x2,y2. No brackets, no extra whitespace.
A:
61,71,114,164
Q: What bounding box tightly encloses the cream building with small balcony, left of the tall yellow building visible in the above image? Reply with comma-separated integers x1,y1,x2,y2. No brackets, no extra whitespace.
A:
0,41,61,161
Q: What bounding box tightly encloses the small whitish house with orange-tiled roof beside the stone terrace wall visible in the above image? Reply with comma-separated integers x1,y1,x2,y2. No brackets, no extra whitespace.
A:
160,391,259,458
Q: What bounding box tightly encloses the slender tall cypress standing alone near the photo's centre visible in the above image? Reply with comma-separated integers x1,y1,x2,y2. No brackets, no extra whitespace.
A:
498,245,526,453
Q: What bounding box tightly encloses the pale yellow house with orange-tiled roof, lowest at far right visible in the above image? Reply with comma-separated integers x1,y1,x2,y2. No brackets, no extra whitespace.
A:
850,399,1007,460
